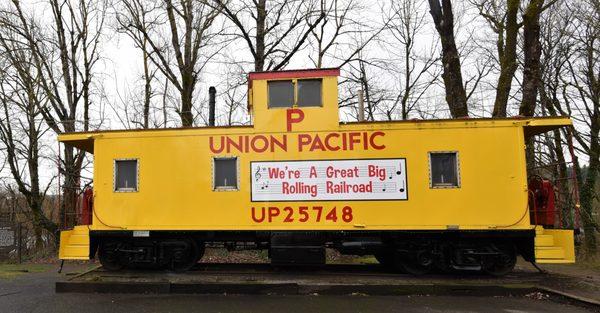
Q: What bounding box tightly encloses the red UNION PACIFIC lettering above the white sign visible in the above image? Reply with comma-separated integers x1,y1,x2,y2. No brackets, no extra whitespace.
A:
208,131,385,153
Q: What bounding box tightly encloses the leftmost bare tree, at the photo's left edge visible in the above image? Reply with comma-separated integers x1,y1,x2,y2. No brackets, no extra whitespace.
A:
0,23,58,244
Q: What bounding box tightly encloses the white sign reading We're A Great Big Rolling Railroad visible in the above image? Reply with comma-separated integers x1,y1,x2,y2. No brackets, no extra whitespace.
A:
250,159,408,201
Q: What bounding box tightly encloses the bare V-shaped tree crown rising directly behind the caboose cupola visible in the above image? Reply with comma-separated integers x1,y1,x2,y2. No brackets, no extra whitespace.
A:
215,0,325,71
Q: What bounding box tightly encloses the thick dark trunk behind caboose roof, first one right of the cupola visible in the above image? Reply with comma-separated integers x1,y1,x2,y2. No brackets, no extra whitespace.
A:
429,0,469,118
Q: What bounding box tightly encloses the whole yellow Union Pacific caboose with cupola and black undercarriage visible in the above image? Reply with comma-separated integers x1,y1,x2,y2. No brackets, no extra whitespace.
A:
59,69,574,274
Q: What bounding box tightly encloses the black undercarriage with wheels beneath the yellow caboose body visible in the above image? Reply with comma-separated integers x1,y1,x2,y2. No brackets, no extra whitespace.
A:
90,230,535,275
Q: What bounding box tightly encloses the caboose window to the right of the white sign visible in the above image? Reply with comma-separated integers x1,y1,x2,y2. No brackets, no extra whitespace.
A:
429,152,460,188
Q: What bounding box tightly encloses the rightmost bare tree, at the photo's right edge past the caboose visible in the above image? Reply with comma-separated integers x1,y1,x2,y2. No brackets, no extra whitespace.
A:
540,0,600,251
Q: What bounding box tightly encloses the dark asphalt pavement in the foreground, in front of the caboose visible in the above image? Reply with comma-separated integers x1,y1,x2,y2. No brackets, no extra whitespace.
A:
0,262,589,313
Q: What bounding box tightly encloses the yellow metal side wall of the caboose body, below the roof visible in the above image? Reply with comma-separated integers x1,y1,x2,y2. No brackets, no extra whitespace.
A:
93,122,529,230
